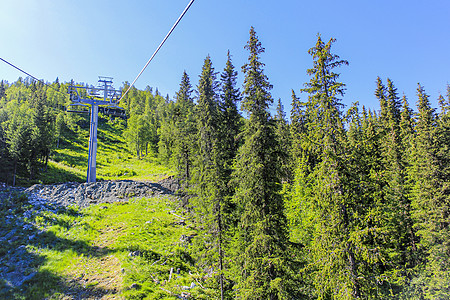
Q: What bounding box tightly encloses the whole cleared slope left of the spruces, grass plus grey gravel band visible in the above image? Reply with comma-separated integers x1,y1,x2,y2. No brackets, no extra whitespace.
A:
0,108,198,299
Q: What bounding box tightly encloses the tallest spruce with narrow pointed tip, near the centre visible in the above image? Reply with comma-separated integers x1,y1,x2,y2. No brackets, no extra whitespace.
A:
234,27,288,299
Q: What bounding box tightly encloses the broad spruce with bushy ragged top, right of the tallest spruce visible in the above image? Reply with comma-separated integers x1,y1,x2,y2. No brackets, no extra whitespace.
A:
292,35,375,299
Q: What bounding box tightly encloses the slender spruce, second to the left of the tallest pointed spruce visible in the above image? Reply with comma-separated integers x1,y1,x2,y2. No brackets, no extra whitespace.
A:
191,56,229,299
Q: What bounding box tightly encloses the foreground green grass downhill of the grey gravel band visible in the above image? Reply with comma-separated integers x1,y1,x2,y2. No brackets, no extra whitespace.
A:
0,196,201,299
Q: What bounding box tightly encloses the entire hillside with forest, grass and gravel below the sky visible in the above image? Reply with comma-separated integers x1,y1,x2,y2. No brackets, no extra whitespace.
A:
0,27,450,299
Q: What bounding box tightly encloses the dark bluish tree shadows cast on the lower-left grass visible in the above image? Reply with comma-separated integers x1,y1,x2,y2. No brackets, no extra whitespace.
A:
0,193,119,299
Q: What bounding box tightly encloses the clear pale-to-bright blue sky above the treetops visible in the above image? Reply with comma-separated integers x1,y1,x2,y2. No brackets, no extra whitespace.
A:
0,0,450,110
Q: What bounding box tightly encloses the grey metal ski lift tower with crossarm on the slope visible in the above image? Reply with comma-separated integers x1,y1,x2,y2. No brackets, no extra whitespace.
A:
69,76,124,183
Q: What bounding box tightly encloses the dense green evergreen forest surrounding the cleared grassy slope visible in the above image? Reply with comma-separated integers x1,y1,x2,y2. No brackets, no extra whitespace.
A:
0,27,450,299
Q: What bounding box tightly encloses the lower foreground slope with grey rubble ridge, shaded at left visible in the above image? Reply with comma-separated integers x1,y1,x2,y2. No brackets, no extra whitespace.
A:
0,180,201,299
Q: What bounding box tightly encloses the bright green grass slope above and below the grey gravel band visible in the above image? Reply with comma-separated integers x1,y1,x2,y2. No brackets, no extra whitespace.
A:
0,113,208,299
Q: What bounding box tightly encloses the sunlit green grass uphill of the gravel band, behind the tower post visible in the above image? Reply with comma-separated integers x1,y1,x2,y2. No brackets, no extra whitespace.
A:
40,119,174,184
